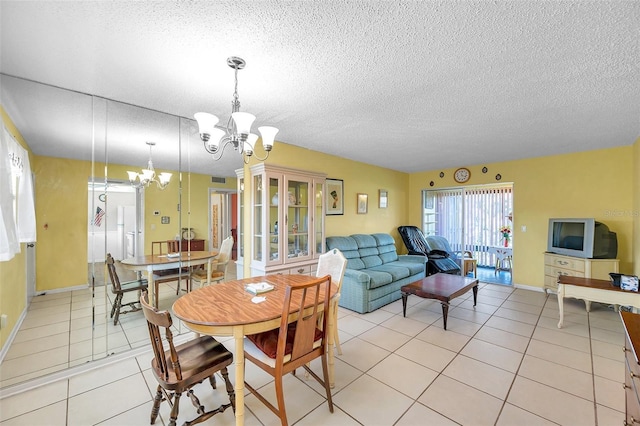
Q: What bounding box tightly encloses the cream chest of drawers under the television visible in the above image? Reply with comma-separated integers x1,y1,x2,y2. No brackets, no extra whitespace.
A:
544,253,620,293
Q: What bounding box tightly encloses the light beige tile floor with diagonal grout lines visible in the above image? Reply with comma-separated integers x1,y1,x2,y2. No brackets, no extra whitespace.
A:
0,284,625,426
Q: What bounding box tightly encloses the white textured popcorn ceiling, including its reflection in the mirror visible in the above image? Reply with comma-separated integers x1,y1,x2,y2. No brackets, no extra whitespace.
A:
0,1,640,175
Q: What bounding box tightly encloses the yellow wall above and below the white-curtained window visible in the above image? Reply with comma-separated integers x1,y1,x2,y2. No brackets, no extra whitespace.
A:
0,106,33,348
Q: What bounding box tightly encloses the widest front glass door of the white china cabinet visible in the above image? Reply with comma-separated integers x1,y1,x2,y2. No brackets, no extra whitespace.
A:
285,179,312,259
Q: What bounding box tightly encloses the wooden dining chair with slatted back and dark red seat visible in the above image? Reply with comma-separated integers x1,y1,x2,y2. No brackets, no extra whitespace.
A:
244,275,333,426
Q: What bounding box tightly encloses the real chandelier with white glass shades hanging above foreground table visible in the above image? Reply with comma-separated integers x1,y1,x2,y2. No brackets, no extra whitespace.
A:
194,56,278,164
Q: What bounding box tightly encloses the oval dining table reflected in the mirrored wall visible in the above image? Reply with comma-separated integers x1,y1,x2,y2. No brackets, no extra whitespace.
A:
121,251,218,307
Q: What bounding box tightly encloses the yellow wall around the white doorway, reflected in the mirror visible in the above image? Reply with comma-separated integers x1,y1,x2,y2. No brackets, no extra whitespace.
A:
35,156,235,292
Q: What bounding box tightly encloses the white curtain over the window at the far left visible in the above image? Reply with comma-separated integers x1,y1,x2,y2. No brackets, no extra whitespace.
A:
0,128,36,261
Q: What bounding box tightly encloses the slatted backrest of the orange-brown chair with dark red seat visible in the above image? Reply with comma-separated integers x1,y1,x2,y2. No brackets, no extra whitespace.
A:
276,275,331,364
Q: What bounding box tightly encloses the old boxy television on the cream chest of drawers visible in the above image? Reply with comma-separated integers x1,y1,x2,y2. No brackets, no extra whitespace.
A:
547,218,618,259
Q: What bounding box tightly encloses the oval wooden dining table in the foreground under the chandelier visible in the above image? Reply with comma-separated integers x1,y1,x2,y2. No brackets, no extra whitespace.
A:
173,275,337,425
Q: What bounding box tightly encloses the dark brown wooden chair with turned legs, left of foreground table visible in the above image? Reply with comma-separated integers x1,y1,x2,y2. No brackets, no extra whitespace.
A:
140,292,236,426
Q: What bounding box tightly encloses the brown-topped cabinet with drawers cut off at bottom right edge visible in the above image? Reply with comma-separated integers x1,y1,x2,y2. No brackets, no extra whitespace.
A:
620,312,640,426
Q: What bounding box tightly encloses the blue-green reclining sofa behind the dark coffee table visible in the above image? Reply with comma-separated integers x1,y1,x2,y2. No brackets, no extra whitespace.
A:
327,234,427,314
